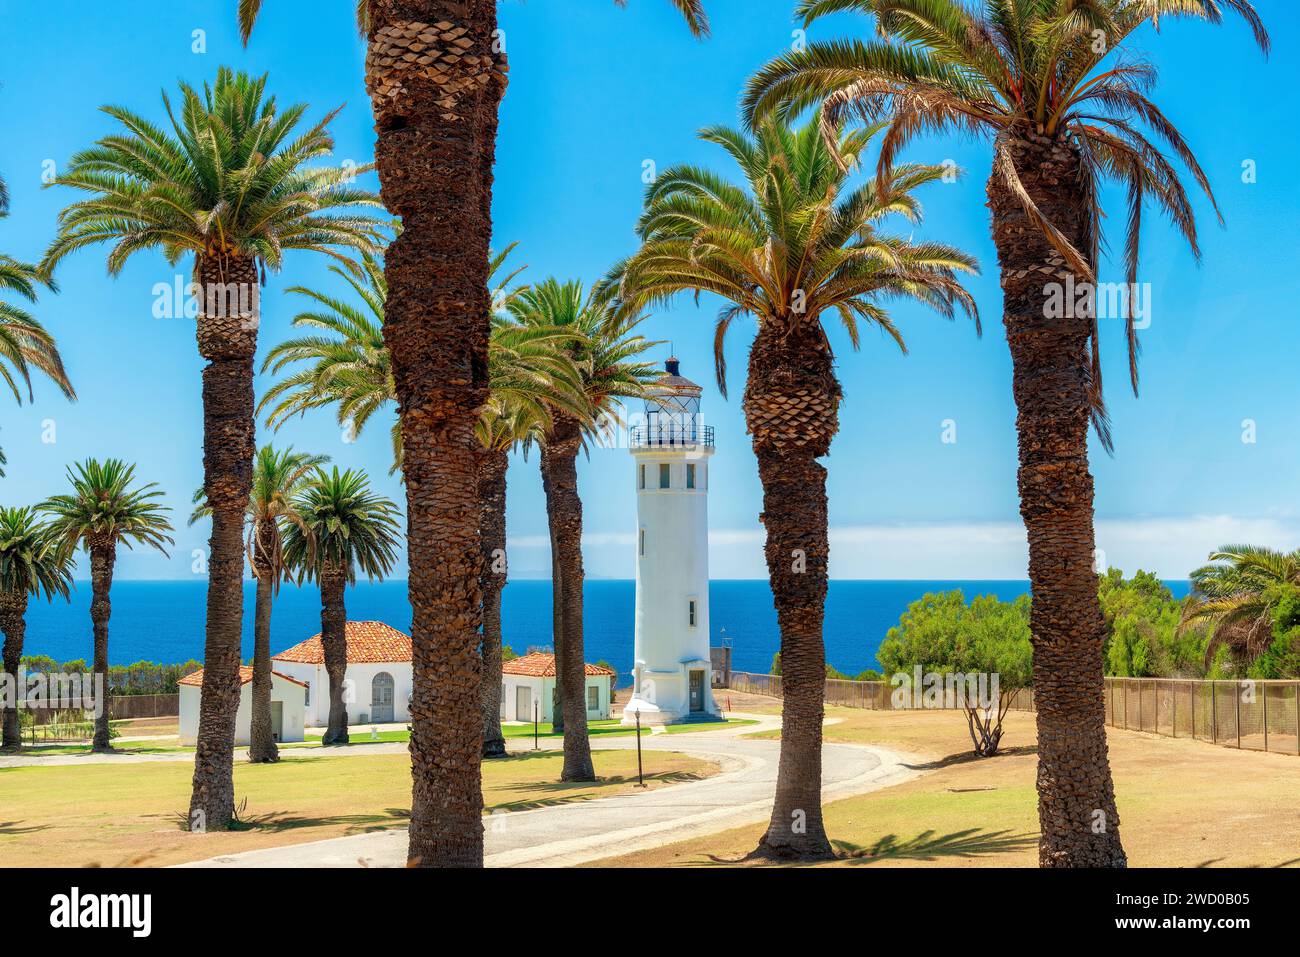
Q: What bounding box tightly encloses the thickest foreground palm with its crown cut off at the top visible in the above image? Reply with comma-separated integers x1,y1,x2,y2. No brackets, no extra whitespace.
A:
238,0,709,867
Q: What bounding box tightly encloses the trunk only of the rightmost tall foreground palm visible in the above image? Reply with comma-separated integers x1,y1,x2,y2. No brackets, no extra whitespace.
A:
988,135,1126,867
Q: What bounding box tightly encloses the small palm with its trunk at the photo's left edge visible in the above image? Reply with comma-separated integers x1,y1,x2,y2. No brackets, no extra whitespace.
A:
0,506,73,750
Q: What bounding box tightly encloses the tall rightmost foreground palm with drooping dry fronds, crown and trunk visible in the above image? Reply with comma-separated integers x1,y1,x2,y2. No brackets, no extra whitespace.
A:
744,0,1269,866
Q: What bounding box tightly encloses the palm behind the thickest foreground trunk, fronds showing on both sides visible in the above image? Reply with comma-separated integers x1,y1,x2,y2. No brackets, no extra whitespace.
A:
257,243,585,757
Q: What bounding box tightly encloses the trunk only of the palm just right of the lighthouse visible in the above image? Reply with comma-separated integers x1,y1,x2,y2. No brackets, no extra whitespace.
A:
744,317,840,858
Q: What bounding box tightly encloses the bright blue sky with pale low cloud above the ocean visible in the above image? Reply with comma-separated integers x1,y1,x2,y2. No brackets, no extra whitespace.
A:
0,0,1300,579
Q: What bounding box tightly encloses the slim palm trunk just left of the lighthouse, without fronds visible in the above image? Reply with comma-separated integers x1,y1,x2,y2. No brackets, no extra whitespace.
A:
542,413,595,781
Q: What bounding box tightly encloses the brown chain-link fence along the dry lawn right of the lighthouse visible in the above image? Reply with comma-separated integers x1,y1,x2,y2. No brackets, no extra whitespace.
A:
731,671,1300,754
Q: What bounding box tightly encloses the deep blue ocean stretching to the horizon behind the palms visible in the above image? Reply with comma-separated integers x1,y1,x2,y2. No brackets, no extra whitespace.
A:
23,581,1187,684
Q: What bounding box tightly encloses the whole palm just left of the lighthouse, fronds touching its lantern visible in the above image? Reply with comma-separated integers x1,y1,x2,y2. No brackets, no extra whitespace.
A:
508,278,655,781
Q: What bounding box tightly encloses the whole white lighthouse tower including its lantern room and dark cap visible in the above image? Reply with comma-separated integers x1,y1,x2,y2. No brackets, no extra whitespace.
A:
623,359,720,724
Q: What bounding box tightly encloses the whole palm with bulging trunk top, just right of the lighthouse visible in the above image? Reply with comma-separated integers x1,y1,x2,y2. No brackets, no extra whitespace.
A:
614,115,978,857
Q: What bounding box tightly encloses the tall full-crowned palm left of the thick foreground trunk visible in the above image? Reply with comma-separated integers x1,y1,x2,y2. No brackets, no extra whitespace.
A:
44,68,381,830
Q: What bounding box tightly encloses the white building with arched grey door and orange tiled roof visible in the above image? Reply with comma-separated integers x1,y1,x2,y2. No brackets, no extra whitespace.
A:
270,622,415,728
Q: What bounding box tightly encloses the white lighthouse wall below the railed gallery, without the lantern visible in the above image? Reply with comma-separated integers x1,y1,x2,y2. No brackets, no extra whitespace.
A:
624,447,718,723
